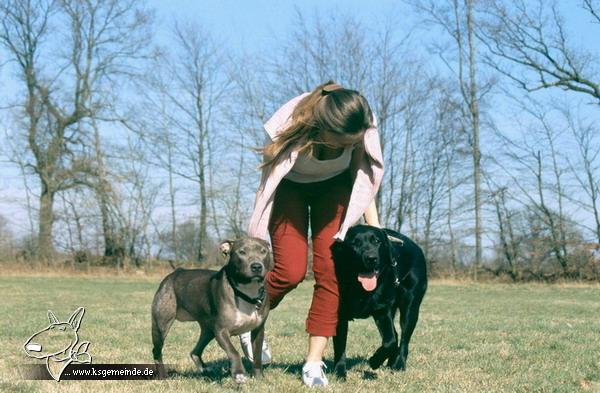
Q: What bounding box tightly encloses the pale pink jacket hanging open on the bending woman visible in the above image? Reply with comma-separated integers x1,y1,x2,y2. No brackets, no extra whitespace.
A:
248,93,383,240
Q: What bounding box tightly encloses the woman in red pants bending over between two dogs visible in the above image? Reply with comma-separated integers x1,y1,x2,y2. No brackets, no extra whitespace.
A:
242,81,383,386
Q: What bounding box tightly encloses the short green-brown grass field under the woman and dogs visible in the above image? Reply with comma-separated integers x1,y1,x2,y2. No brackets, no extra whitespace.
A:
0,275,600,393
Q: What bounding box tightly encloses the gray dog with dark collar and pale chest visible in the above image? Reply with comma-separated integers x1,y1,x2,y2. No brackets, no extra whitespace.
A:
152,238,272,383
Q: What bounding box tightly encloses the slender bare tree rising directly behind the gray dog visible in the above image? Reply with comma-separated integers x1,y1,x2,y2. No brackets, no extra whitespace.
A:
149,20,231,261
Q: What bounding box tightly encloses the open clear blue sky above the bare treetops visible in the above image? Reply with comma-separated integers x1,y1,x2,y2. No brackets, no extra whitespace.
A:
148,0,600,55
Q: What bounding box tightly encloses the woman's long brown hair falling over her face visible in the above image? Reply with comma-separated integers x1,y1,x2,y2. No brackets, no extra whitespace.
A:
258,80,373,168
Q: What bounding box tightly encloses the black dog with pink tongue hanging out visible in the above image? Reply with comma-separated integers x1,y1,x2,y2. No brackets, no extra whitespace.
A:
332,225,427,378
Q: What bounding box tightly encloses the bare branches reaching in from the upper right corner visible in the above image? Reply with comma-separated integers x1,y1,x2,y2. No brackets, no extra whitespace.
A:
480,0,600,104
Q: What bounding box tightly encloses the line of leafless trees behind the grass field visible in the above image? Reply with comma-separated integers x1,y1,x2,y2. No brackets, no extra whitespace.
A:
0,0,600,281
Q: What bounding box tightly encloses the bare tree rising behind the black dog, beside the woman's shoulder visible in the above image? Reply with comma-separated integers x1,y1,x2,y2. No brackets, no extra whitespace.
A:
369,41,435,230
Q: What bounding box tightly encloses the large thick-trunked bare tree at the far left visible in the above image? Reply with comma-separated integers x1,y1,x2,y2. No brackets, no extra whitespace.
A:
0,0,149,259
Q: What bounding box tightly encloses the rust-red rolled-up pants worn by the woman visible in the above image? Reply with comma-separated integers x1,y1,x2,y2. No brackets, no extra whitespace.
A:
267,172,352,337
